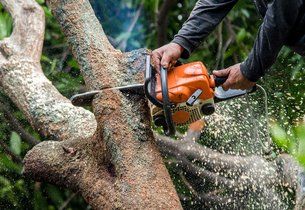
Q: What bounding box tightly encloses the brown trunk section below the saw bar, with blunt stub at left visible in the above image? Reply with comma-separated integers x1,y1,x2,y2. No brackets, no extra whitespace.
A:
24,83,180,209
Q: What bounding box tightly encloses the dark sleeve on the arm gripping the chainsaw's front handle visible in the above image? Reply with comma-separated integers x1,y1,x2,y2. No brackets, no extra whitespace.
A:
172,0,238,58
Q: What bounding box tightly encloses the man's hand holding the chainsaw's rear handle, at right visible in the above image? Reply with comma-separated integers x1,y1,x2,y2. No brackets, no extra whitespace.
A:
213,63,256,90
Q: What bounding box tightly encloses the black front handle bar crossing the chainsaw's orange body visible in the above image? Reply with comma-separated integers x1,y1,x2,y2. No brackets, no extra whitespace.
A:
160,66,176,136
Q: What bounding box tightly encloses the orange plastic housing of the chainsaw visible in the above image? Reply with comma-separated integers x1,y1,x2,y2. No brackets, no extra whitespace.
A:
156,62,215,104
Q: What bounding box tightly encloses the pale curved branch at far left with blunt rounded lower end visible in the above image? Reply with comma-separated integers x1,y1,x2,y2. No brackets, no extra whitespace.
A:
0,0,96,140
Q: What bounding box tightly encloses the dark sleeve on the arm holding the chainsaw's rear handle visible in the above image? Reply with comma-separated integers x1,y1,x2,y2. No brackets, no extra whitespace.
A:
241,0,303,82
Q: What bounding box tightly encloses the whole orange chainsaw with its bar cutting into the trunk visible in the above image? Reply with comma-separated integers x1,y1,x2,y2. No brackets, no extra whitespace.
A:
71,56,256,136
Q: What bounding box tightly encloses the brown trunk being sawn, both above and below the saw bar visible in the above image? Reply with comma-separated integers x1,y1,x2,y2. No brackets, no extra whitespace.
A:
20,0,181,209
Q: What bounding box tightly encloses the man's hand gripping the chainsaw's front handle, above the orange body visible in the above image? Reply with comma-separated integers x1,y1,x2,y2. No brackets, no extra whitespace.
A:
152,43,184,72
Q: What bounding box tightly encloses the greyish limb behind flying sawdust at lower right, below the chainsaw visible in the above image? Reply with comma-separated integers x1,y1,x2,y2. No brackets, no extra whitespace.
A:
157,123,305,209
